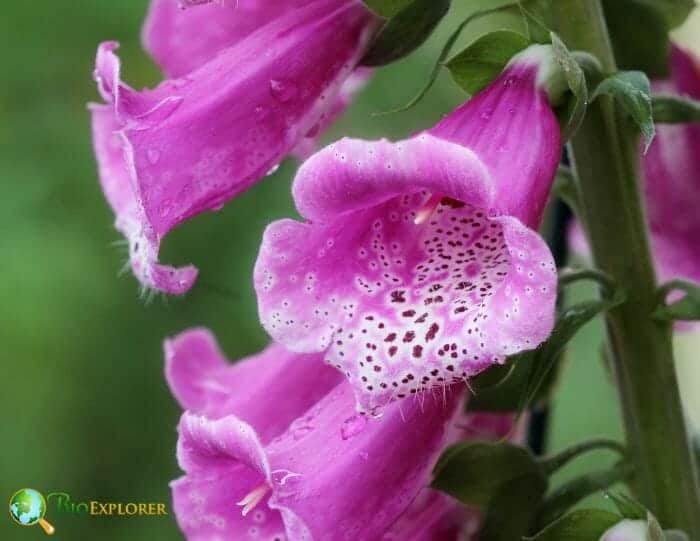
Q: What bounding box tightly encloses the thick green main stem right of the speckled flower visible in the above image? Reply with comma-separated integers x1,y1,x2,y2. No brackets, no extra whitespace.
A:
552,0,700,539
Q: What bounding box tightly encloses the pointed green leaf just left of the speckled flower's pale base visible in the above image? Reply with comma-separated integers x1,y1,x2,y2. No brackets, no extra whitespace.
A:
445,30,530,95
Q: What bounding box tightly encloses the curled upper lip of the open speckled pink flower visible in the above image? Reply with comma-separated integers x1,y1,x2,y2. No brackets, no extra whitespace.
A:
292,134,494,222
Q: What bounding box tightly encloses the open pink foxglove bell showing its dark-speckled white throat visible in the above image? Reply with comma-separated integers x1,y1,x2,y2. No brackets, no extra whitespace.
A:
255,46,561,412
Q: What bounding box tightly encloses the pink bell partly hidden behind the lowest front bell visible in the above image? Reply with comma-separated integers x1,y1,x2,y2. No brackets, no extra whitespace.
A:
164,329,342,436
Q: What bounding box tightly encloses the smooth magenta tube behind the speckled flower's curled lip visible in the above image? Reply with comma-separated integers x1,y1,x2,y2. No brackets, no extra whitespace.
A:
430,59,561,229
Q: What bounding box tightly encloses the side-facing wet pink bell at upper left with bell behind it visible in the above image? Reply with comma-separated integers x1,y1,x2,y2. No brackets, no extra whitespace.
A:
90,0,377,294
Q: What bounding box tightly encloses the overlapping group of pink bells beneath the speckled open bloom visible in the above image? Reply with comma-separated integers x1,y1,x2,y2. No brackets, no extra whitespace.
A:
165,330,512,541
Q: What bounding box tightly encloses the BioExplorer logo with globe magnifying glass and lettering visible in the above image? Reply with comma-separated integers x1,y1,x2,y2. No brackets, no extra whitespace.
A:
10,488,168,535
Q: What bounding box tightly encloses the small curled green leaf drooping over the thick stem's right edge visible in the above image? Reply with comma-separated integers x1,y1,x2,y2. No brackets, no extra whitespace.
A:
592,71,656,148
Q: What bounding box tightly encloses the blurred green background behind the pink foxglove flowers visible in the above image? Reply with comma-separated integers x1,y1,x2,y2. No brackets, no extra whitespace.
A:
0,0,619,541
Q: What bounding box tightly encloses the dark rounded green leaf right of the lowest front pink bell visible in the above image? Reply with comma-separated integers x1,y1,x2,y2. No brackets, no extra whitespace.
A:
431,441,547,507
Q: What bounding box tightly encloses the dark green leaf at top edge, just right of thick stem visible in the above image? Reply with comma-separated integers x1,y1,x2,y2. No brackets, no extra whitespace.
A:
603,0,671,78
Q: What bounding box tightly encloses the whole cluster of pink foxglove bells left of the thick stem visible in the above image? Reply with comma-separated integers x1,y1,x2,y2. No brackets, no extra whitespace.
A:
91,0,576,541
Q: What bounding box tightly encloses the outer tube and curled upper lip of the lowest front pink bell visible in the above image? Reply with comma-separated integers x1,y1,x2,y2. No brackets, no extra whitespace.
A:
174,383,463,540
